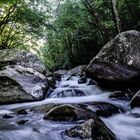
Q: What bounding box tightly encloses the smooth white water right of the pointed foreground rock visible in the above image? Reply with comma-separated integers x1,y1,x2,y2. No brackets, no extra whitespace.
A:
103,108,140,140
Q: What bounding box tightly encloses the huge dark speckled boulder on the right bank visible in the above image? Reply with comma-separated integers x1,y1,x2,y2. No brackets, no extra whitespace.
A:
86,30,140,88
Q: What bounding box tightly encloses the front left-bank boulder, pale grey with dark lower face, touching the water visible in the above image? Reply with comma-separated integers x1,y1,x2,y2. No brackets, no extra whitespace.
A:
0,65,48,104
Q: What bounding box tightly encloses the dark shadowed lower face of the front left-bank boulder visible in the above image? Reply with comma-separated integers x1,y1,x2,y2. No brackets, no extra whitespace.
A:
0,76,34,104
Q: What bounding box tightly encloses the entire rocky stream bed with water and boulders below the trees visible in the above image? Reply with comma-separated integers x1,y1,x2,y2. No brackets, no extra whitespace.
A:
0,31,140,140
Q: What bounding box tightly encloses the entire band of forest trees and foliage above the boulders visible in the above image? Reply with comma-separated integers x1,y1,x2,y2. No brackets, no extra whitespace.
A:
0,0,140,69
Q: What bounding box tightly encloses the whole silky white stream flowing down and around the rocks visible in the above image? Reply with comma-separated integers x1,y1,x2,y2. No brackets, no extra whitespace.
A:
0,75,140,140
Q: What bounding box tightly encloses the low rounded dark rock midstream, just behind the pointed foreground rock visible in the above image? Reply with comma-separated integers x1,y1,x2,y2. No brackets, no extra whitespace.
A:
44,104,93,121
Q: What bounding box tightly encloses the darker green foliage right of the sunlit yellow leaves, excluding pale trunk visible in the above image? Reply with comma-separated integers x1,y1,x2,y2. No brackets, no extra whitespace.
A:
42,0,140,69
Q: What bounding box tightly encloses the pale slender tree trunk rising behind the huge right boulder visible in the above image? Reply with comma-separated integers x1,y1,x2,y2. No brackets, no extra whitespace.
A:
111,0,122,33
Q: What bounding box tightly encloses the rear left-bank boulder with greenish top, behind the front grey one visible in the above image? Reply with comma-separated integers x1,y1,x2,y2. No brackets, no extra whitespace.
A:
0,49,50,75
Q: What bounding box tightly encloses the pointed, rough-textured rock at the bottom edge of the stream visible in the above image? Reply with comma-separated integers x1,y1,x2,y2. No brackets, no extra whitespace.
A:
65,116,116,140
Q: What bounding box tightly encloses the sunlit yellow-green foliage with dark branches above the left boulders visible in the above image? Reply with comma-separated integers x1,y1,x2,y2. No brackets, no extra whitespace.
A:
0,0,50,49
